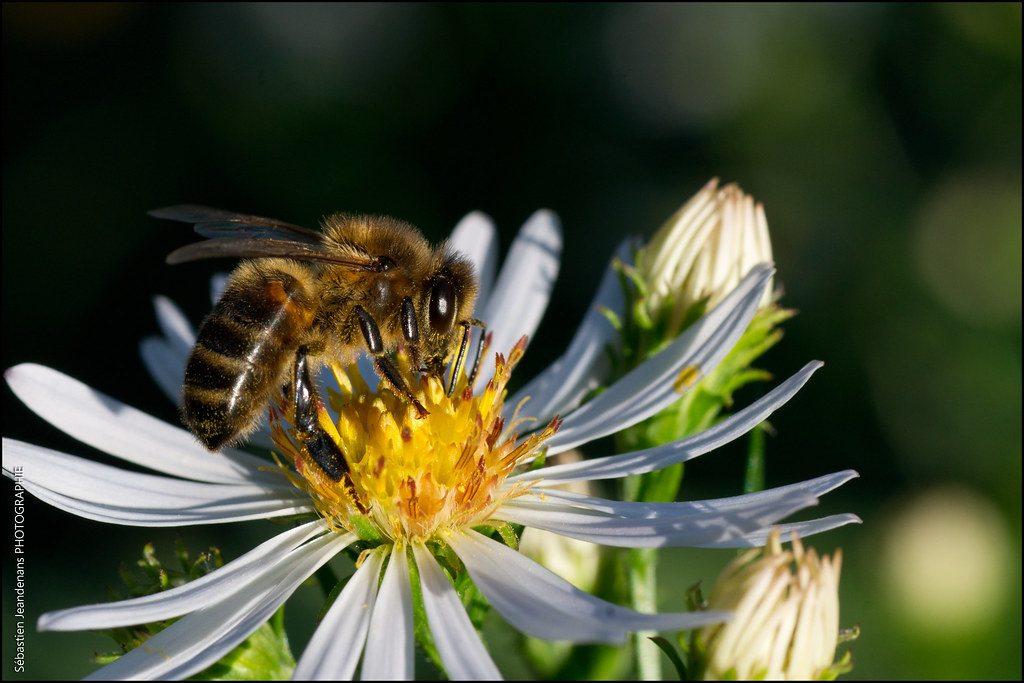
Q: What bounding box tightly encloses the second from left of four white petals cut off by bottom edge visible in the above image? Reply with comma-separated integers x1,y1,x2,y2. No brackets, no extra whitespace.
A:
292,553,384,681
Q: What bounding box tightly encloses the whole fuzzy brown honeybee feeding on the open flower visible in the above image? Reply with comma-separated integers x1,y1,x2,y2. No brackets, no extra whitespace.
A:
150,205,485,481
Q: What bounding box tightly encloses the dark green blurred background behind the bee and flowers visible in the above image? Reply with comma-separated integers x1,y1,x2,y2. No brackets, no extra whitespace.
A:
2,3,1021,680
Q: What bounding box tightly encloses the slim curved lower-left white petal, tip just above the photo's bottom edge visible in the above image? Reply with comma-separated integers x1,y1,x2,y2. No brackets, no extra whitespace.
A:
39,519,331,631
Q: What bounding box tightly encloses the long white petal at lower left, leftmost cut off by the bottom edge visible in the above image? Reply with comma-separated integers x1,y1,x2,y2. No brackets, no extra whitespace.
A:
81,533,352,680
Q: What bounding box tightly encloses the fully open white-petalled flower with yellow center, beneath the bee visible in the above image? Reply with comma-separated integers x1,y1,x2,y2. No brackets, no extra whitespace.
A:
3,211,859,679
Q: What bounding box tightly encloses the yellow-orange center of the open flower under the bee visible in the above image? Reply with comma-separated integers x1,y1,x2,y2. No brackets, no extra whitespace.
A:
271,338,560,541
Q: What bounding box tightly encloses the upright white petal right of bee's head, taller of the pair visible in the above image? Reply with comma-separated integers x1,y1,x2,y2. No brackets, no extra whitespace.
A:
476,209,562,385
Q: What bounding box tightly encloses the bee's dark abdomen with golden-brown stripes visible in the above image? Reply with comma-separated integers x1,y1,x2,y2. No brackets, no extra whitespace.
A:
182,259,315,451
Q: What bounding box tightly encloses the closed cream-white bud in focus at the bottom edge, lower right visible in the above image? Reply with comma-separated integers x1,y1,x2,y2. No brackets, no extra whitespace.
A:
699,529,843,681
